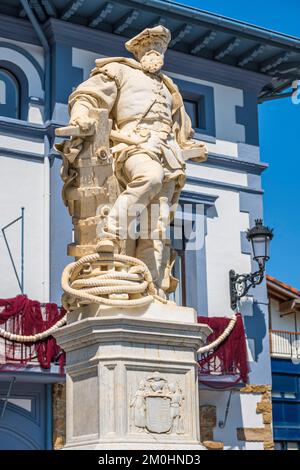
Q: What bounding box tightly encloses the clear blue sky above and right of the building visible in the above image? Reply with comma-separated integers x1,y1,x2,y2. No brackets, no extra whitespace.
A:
173,0,300,289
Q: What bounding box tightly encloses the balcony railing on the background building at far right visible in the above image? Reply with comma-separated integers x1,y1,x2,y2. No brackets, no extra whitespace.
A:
270,330,300,359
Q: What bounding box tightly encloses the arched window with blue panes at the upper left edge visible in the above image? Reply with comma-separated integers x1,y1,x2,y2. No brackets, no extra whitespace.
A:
0,68,20,119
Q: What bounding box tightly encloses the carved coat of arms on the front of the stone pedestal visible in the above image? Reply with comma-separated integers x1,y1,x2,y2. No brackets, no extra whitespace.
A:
130,372,184,434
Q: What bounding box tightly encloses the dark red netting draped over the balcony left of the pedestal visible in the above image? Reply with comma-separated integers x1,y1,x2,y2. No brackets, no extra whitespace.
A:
0,295,66,372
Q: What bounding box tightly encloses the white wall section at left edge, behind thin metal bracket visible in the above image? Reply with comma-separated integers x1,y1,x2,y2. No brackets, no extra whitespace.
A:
0,156,44,300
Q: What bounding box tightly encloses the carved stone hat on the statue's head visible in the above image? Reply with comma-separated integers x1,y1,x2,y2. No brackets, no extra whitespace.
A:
125,25,171,56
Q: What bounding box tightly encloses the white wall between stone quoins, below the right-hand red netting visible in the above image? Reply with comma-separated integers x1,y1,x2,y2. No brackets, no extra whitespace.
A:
200,390,264,450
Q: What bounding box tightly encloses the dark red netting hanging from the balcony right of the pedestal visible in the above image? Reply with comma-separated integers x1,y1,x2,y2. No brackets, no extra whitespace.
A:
198,313,249,383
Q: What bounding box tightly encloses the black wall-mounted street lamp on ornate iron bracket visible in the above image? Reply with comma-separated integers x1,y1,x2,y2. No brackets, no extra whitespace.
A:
229,219,273,310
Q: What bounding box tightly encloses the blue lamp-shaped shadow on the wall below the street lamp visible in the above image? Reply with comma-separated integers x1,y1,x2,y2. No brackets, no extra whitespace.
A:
243,302,267,362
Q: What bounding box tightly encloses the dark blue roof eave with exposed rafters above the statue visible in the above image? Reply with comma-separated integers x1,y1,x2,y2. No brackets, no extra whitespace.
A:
0,0,300,101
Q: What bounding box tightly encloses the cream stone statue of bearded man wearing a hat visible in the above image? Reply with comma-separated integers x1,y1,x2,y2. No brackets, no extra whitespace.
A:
64,26,207,295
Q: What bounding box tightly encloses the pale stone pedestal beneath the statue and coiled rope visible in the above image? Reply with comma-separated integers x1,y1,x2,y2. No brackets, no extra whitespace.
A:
55,303,211,450
